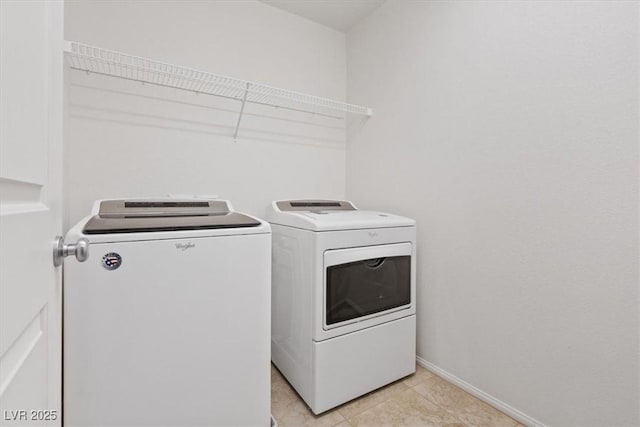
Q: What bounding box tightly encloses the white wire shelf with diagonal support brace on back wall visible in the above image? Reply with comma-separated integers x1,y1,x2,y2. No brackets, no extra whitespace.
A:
65,41,373,123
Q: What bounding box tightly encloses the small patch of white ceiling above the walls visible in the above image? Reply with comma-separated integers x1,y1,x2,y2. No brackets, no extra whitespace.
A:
262,0,385,32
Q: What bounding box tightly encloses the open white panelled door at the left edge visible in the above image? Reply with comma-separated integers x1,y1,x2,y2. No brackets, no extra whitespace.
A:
0,0,63,426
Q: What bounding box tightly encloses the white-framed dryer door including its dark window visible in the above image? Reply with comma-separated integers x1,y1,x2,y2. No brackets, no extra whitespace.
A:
323,243,411,330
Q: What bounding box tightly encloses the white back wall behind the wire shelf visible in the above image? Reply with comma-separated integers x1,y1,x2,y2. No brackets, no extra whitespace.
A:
65,1,346,228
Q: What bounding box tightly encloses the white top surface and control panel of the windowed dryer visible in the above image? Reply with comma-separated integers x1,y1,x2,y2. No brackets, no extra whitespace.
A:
267,200,416,231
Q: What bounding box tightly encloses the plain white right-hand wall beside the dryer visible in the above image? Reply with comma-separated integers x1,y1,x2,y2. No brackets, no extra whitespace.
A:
347,1,640,426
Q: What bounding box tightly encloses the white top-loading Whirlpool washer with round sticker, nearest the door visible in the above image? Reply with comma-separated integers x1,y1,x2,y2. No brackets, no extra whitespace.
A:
63,199,271,427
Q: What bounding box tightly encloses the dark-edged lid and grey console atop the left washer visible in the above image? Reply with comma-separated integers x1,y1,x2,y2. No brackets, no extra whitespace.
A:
82,199,260,234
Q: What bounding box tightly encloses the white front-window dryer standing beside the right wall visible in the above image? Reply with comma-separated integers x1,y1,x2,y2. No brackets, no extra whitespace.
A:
267,200,416,414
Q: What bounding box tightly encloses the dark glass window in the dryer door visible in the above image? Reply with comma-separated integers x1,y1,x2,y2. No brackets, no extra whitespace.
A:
325,255,411,325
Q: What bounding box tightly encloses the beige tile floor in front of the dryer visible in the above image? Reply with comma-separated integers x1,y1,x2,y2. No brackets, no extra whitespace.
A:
271,365,522,427
